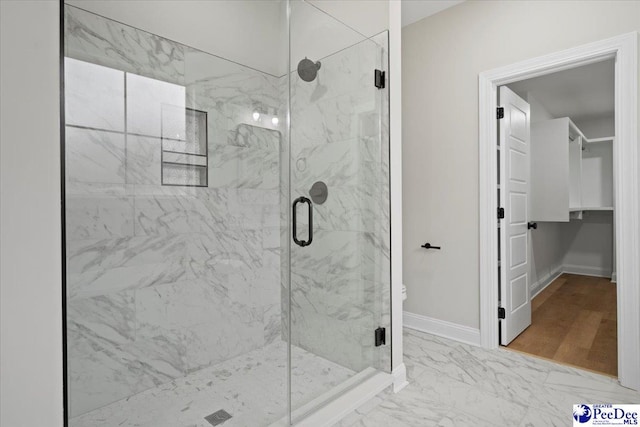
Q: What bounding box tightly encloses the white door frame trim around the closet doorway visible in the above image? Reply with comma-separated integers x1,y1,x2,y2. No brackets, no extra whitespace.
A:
478,31,640,390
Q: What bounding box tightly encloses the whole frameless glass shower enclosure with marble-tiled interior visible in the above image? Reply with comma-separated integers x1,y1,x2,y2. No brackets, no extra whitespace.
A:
62,0,391,427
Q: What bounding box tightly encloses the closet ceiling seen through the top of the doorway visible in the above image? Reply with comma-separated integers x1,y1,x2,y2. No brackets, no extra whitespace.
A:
508,59,614,122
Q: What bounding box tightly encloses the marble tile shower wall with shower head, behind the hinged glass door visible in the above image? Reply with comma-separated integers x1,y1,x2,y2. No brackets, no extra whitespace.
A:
291,34,390,371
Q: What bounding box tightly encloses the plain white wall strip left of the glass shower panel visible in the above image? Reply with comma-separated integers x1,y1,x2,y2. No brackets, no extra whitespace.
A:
0,1,62,427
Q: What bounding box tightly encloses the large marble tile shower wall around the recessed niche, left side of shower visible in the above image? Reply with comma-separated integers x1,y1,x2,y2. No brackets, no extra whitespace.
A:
65,6,284,417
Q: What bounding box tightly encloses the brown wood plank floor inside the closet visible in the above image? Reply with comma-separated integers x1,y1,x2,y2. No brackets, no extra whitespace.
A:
507,274,618,376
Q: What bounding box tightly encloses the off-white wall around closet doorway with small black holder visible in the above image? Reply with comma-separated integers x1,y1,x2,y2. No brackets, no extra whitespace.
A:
402,1,640,328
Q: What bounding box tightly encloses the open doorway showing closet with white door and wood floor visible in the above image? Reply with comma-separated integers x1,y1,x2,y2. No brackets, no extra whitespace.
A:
497,59,617,376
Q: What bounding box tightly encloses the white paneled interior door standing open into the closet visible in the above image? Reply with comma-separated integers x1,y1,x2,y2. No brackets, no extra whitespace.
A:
498,87,531,345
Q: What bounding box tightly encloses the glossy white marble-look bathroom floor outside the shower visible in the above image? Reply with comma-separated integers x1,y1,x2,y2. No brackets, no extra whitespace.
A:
339,330,640,427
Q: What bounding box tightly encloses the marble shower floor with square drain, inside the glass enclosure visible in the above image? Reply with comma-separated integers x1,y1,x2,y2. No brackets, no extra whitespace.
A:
69,341,355,427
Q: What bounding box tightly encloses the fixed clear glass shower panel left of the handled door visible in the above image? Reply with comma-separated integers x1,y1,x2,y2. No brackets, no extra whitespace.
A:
63,1,289,427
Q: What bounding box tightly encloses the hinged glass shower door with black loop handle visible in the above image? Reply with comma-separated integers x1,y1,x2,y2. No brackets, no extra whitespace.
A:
282,1,391,422
